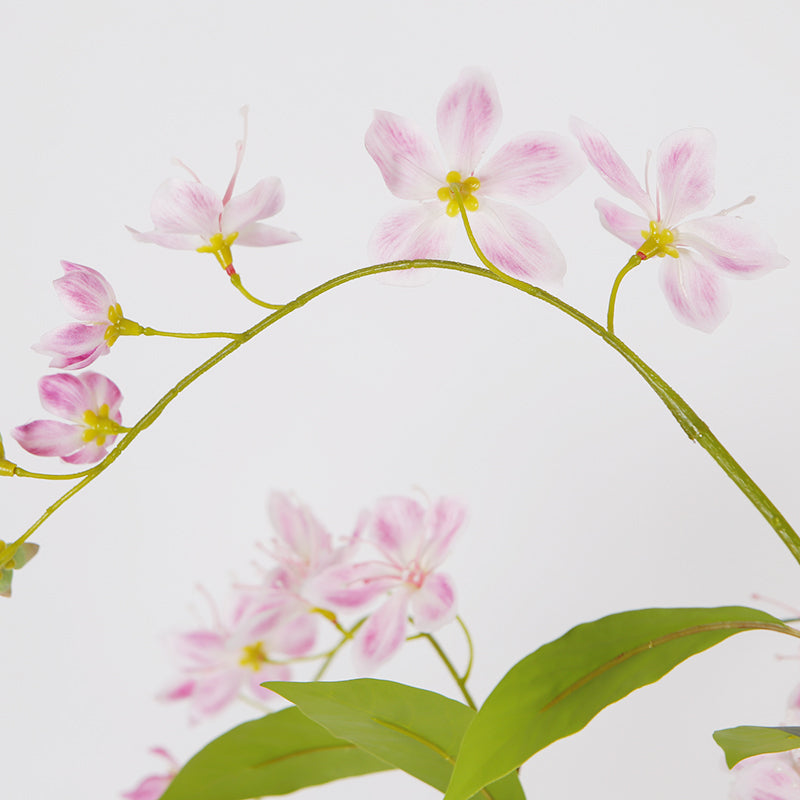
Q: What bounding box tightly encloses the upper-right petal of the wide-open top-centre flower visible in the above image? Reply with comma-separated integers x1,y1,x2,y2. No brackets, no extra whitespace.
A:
478,132,585,204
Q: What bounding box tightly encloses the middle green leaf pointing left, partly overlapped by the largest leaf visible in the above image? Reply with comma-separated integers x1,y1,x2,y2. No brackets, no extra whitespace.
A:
264,678,525,800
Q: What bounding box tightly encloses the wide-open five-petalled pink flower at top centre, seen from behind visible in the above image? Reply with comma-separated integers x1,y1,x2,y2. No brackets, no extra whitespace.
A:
365,69,583,281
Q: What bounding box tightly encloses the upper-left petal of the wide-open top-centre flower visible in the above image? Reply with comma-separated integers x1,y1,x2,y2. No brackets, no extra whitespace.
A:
364,111,447,200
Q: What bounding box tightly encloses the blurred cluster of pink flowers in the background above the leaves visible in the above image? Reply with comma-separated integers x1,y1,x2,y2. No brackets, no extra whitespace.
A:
162,492,465,720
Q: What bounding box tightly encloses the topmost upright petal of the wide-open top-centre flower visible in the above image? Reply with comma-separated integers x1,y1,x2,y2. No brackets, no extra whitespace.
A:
436,68,503,179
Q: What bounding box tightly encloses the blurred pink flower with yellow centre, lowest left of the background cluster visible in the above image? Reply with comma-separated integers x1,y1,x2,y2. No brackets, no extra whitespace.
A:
161,595,314,721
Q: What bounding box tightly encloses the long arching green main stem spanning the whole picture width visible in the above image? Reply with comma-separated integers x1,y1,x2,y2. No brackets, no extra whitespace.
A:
0,259,800,568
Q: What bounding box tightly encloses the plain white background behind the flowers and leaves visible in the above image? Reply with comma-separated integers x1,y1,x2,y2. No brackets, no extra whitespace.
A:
0,0,800,800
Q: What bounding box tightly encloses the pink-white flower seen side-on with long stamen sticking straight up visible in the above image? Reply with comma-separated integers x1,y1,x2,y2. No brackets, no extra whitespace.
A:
128,107,300,275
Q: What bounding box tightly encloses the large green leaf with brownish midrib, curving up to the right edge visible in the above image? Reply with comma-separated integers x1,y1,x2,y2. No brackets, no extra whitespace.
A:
446,607,800,800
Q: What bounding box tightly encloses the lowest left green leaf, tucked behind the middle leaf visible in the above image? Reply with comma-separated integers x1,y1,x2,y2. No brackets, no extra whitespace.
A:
162,708,391,800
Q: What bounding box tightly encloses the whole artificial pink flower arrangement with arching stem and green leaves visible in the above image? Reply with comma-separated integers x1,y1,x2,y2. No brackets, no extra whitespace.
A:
0,69,800,800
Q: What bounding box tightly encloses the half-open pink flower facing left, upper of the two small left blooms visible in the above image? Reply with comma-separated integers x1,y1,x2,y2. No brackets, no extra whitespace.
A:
33,261,142,369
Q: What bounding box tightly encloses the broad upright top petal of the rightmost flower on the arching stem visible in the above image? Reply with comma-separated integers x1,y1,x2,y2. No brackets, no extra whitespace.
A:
656,128,716,227
